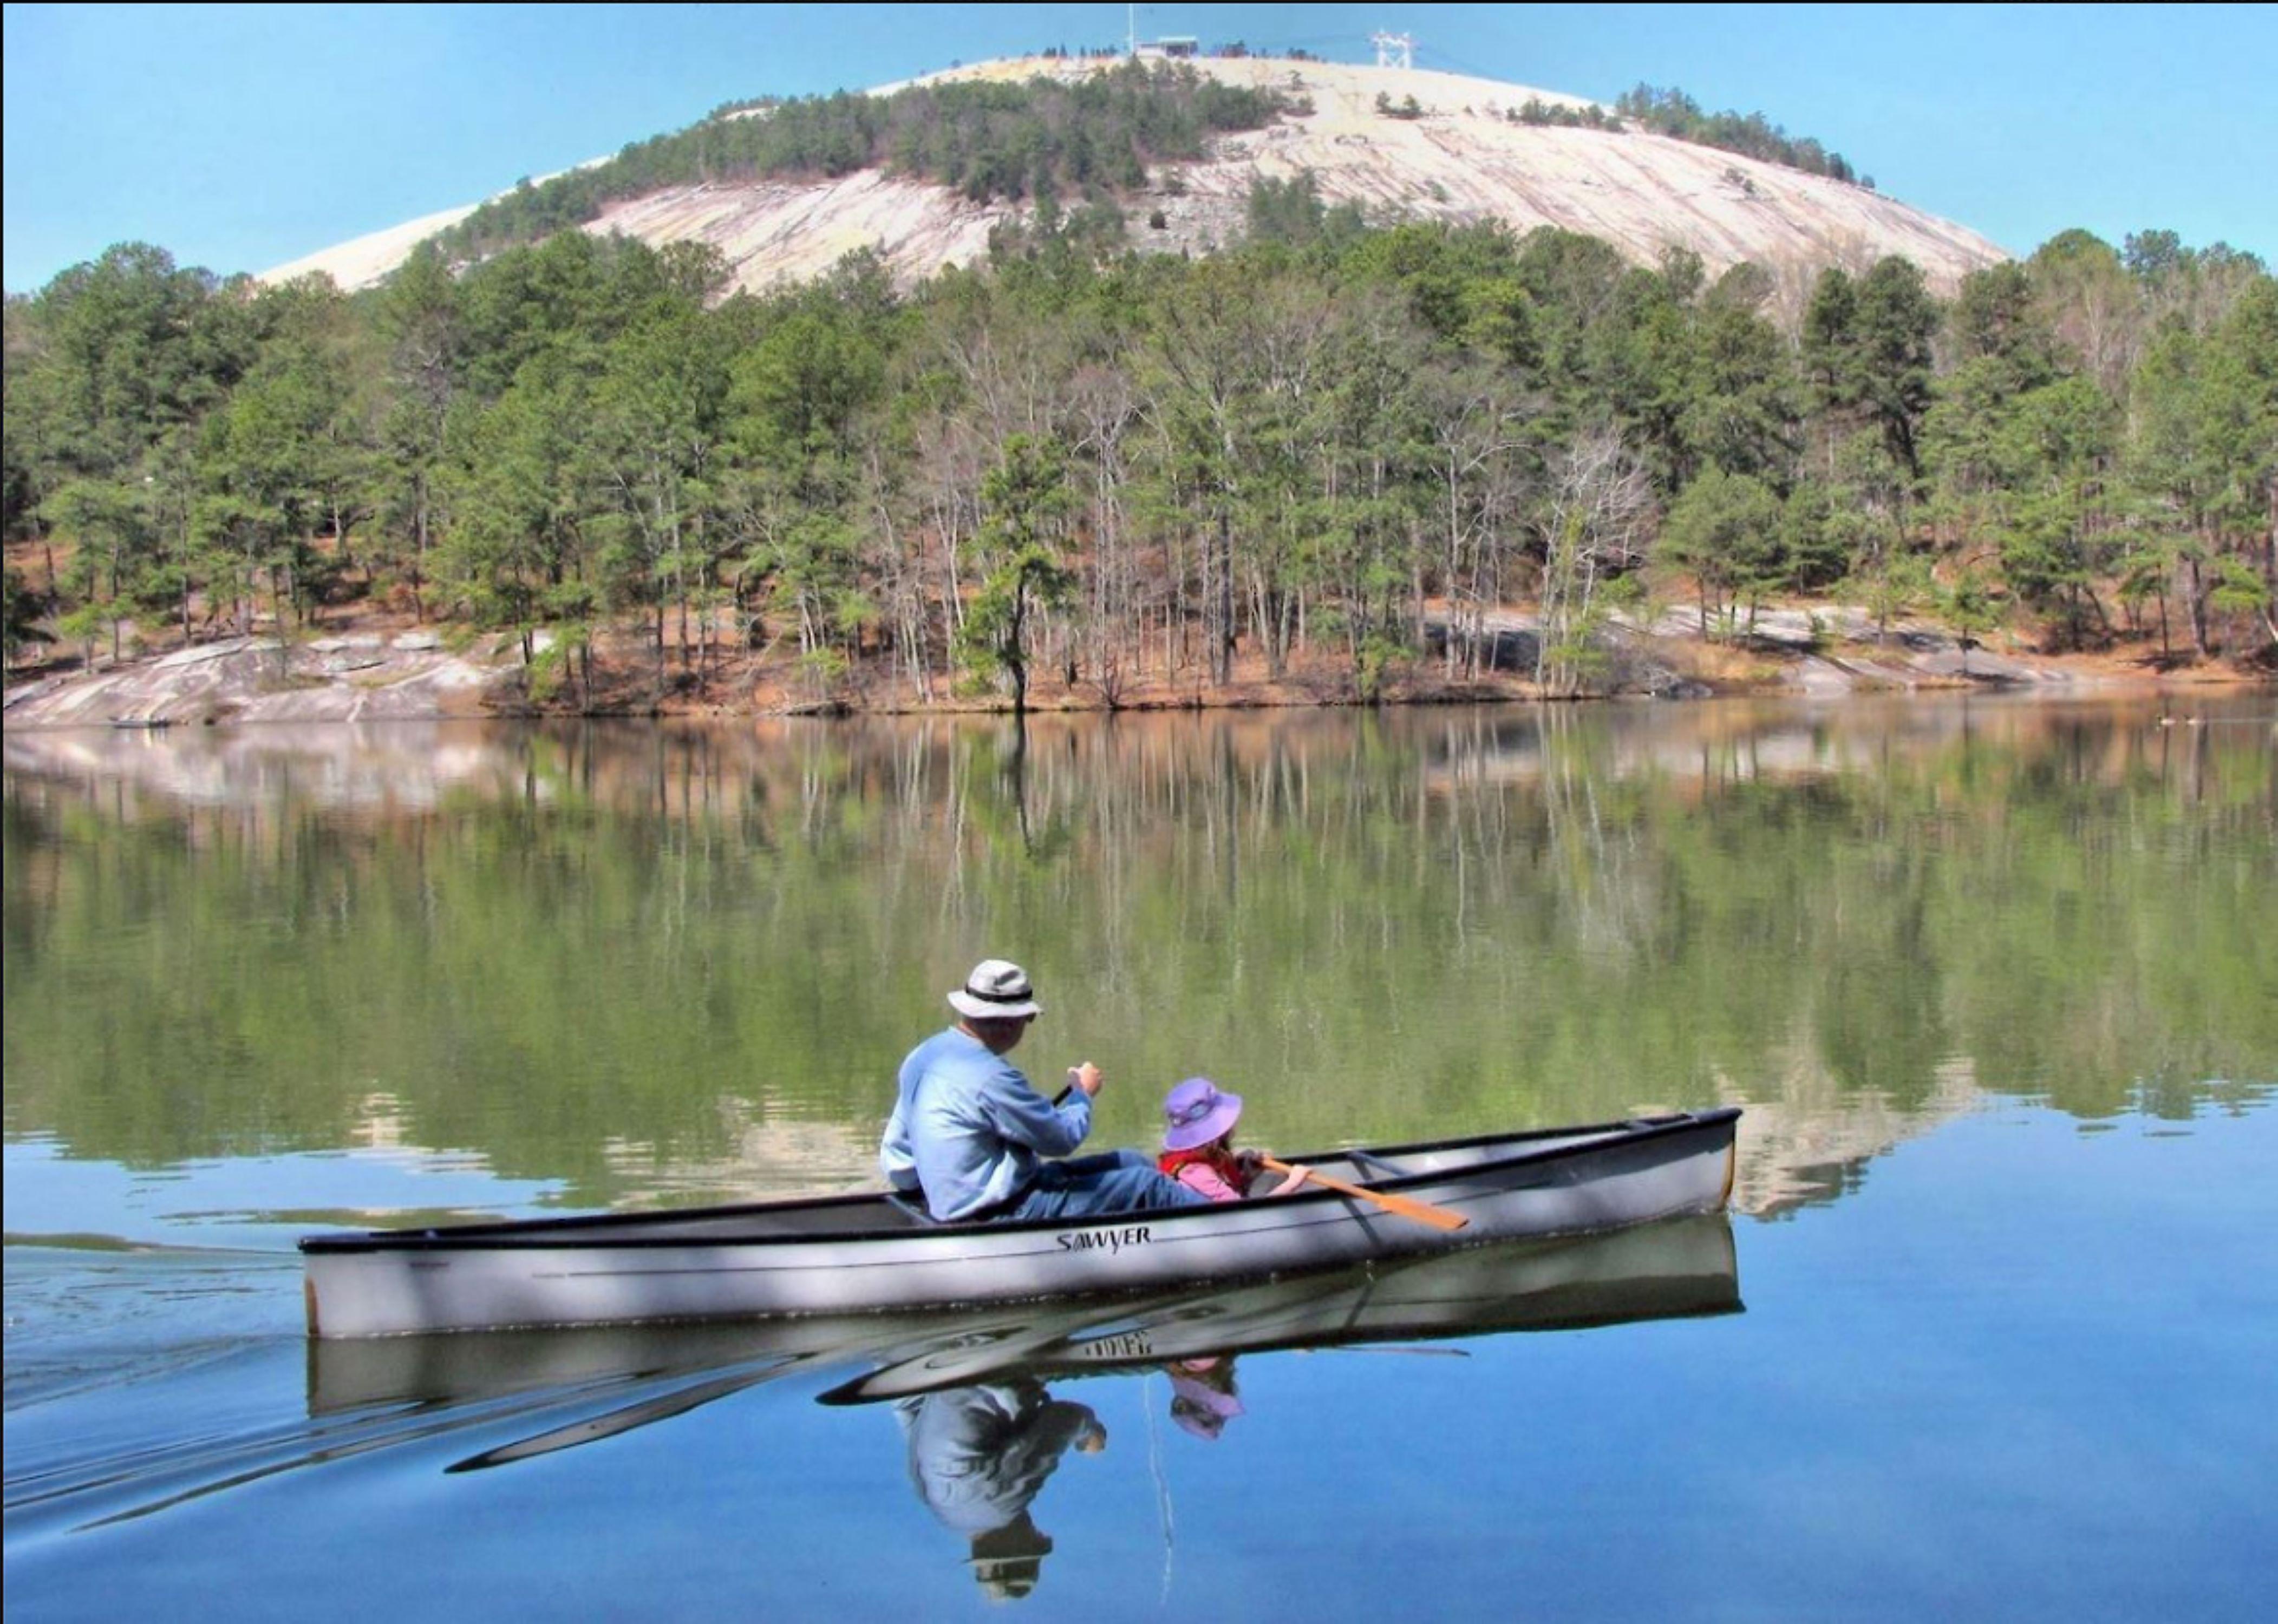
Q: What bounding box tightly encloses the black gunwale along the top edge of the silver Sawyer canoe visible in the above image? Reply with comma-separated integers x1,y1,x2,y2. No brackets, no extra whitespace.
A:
298,1105,1740,1258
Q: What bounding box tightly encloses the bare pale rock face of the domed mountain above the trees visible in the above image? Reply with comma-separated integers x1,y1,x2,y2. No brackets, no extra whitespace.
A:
264,57,2009,307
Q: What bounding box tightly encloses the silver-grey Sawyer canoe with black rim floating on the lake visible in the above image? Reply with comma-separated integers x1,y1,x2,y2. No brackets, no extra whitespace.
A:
301,1109,1740,1337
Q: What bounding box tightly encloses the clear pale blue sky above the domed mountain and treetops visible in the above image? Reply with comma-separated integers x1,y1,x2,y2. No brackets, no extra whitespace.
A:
0,4,2278,292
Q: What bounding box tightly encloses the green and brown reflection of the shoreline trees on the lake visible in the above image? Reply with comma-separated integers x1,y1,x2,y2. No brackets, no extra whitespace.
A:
4,702,2278,1200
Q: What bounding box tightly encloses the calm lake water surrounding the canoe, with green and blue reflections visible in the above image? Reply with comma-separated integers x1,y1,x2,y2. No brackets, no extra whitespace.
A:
4,692,2278,1624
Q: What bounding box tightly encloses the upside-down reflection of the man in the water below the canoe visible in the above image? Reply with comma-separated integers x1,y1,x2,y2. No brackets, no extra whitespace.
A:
895,1376,1107,1599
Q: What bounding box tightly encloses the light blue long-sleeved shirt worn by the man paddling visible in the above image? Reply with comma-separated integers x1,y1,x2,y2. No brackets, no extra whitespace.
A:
877,1027,1091,1219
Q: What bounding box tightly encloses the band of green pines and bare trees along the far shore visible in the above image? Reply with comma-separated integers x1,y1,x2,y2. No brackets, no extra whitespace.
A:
4,180,2278,709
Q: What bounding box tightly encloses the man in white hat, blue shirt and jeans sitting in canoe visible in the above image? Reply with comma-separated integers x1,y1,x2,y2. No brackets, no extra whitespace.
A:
877,959,1210,1223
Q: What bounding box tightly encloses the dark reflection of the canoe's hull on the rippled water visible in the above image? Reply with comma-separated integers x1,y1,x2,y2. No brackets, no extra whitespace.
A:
308,1214,1740,1469
